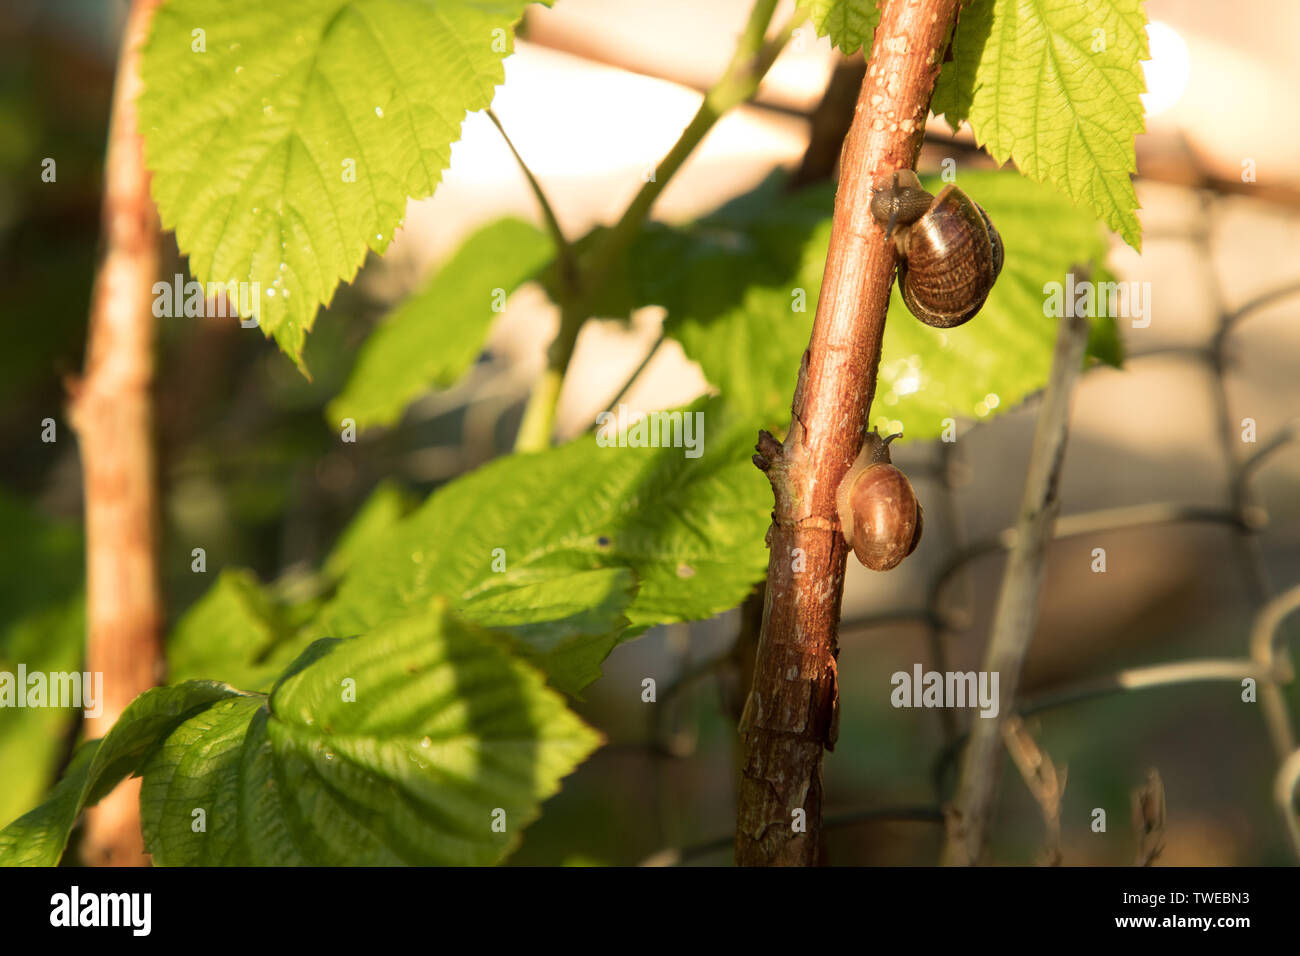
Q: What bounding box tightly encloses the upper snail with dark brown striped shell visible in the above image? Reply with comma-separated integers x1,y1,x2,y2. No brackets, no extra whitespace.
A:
871,169,1002,329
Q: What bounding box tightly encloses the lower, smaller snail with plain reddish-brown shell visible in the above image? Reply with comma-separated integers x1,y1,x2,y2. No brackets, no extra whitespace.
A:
836,429,922,571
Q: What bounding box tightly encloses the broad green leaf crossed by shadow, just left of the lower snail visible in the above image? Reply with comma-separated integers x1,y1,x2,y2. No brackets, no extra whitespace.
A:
315,401,771,689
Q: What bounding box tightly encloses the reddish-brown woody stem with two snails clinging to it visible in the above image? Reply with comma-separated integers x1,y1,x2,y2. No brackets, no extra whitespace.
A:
736,0,957,866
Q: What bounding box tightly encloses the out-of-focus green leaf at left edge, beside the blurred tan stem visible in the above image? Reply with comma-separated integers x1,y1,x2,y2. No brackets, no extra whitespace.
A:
0,494,86,823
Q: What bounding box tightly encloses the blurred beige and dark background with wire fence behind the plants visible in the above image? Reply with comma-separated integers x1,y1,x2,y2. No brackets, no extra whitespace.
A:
0,0,1300,865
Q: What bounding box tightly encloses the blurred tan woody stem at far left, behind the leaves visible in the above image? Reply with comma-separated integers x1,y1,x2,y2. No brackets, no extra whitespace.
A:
69,0,163,866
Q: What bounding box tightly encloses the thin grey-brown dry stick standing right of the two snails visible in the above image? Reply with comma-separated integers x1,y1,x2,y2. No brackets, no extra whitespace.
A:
944,316,1088,865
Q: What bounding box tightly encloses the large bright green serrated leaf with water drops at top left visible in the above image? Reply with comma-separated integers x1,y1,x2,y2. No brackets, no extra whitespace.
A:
138,0,546,363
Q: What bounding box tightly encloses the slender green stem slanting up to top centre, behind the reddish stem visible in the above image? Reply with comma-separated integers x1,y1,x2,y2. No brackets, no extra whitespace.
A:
515,0,806,451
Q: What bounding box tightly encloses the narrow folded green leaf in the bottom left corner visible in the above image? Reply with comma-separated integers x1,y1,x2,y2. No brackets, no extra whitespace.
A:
0,682,242,866
